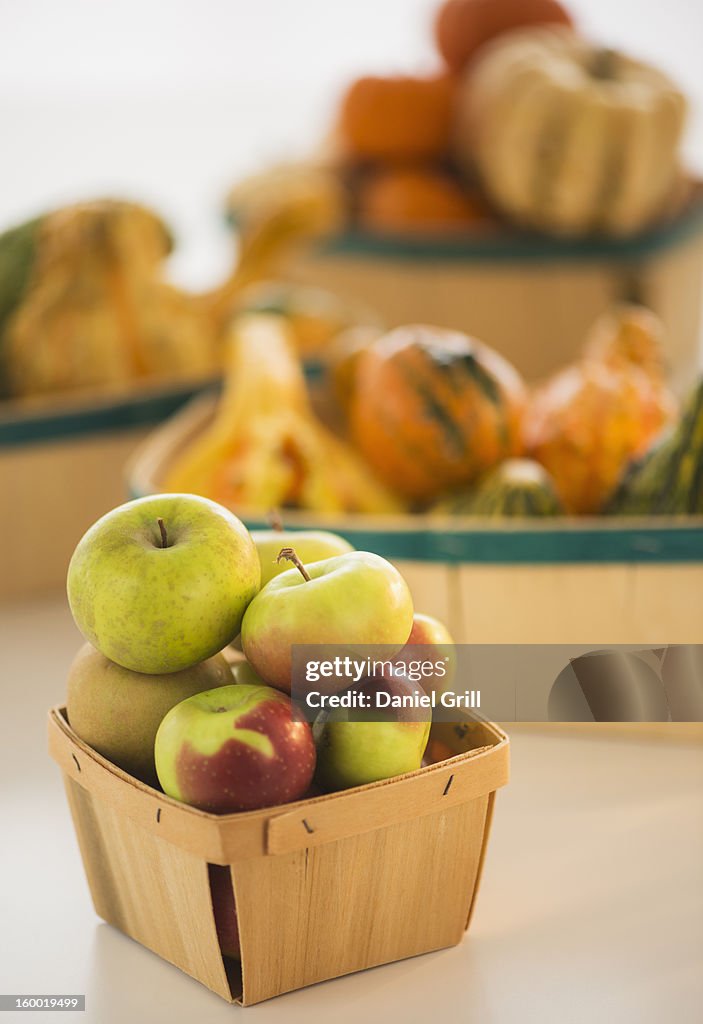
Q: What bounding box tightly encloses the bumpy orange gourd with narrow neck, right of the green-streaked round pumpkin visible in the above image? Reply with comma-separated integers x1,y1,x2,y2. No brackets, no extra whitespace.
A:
525,315,676,514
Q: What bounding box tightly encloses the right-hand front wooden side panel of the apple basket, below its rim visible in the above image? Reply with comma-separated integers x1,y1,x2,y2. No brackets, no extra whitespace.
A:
232,796,488,1005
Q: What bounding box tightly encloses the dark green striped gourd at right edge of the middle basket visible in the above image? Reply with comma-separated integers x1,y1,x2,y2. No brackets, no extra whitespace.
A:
604,380,703,515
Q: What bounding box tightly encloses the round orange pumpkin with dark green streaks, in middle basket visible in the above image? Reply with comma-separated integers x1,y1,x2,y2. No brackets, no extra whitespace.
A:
350,325,525,501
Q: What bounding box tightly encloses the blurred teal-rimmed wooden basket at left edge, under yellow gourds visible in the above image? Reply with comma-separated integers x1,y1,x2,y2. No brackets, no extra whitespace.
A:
0,380,216,601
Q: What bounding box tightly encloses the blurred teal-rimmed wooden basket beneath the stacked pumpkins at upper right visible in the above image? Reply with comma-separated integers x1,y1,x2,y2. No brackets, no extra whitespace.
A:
285,197,703,393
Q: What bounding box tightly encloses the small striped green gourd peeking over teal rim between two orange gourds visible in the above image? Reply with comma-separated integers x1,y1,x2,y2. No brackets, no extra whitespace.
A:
435,459,564,517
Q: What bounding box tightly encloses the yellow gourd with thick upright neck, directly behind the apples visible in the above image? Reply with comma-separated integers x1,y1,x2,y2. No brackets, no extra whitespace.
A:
165,314,400,513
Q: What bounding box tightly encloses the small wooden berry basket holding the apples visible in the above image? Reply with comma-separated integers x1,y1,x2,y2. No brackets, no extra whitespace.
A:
49,708,509,1005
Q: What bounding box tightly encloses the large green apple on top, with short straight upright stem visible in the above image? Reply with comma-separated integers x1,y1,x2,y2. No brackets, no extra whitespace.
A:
68,495,261,674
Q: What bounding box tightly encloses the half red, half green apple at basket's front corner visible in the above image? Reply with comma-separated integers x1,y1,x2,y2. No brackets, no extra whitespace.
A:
155,683,315,814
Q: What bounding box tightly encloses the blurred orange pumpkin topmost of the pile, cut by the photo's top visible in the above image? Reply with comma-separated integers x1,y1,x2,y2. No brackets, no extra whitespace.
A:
435,0,573,72
